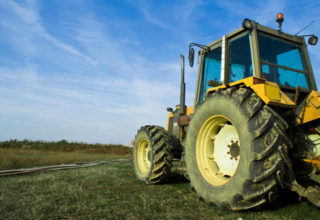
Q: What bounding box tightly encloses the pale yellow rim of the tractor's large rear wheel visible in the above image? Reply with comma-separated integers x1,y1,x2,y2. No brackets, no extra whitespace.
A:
196,115,240,186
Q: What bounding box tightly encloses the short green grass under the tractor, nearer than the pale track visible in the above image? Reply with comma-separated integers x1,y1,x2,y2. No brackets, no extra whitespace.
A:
0,163,320,220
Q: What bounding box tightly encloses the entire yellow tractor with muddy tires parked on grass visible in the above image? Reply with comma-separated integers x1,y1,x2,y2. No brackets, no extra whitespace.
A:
133,13,320,210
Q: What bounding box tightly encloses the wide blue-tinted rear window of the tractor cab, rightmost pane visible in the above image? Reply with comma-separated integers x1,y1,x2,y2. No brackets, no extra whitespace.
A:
258,33,310,90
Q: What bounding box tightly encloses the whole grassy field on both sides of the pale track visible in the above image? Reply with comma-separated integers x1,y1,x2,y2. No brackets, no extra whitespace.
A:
0,140,320,219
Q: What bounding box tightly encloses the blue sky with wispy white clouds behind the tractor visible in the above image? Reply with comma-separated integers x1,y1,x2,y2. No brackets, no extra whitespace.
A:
0,0,320,145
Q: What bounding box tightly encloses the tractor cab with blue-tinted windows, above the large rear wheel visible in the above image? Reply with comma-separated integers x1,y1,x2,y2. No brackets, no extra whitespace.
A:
189,15,317,108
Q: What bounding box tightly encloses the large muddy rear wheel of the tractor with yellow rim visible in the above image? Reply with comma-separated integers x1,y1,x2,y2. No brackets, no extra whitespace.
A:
186,88,291,210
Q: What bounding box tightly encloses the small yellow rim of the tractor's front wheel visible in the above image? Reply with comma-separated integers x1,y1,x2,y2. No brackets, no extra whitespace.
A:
137,138,151,173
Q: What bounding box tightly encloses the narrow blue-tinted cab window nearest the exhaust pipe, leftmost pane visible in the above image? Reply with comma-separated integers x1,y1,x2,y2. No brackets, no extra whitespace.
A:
200,47,221,102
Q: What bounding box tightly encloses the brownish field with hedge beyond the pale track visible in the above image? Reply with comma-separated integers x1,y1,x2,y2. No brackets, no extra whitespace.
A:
0,140,132,170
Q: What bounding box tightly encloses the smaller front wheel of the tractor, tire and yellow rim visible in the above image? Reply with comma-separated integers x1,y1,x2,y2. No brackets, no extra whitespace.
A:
133,125,172,184
